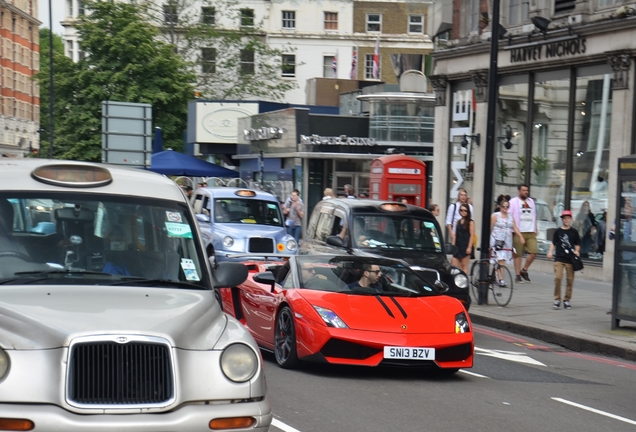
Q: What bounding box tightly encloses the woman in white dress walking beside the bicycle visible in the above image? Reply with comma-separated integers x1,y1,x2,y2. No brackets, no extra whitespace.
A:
490,197,526,286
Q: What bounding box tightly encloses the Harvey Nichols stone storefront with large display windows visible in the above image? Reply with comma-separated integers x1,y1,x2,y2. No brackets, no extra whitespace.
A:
432,0,636,278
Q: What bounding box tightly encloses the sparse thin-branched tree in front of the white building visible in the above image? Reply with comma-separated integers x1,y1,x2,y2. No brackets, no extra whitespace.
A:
145,0,297,101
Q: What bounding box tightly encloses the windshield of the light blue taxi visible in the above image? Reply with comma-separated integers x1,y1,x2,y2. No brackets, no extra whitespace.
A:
214,198,283,227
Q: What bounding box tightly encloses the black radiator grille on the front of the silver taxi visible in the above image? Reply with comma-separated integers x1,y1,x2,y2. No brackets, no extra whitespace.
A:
68,341,174,405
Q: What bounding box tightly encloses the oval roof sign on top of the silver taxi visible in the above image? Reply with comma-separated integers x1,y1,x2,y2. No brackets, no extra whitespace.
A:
31,164,113,188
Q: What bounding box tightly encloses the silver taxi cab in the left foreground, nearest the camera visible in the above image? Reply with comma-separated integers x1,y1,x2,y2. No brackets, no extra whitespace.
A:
0,159,272,432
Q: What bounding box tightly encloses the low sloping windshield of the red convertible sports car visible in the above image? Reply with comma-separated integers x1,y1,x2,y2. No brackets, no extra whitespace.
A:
296,255,439,297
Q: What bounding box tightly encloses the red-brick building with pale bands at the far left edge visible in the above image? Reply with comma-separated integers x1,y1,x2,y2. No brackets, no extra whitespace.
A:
0,0,40,157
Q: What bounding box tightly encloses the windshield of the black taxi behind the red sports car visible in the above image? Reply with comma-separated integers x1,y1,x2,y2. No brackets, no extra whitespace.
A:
352,215,442,253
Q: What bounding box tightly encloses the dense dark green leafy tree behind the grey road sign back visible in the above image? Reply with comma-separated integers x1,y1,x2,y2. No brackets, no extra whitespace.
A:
40,0,195,161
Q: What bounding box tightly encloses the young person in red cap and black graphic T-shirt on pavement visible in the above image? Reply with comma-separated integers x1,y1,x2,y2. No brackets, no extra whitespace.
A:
546,210,581,309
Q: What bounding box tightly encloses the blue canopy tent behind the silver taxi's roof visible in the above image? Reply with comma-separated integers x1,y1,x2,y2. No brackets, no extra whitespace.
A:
148,150,239,178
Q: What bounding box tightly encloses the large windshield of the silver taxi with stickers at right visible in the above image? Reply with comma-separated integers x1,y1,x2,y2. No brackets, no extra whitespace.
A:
0,192,209,288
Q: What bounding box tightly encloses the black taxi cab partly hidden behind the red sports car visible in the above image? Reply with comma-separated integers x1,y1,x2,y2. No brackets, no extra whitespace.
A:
300,198,470,309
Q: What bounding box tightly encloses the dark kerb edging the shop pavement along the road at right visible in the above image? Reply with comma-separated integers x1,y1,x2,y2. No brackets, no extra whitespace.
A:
468,311,636,361
